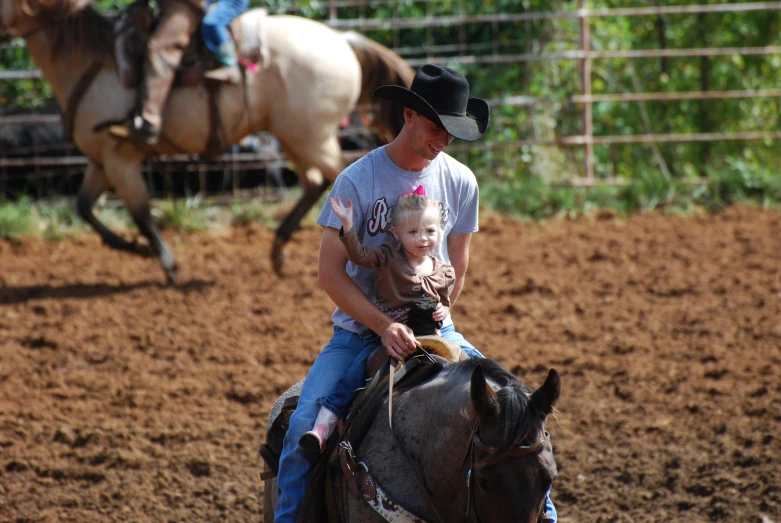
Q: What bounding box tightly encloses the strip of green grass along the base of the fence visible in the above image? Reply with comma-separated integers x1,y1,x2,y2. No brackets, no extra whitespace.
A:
0,168,781,246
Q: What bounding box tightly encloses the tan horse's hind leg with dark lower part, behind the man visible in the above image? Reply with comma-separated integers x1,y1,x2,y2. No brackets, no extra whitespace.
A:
271,135,342,274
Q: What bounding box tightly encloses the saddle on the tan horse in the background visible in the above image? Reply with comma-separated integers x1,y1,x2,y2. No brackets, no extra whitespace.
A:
114,0,268,89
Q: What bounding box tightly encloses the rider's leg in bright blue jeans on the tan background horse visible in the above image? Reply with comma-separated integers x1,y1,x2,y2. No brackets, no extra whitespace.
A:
201,0,248,83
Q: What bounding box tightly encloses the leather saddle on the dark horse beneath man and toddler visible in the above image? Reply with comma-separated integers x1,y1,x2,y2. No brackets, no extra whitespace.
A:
258,336,464,523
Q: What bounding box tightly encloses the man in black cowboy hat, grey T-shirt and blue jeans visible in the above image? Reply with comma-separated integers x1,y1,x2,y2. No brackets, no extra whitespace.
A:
274,64,555,523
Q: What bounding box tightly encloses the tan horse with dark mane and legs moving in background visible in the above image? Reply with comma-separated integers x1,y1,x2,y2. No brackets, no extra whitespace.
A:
0,0,414,282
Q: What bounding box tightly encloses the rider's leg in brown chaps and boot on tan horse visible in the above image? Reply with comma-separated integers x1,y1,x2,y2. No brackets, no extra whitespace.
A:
139,0,201,136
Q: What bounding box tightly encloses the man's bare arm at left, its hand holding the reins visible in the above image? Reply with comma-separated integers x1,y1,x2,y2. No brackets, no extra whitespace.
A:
317,227,416,359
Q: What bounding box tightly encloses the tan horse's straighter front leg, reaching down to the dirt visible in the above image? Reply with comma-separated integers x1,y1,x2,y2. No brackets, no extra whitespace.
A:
104,157,177,284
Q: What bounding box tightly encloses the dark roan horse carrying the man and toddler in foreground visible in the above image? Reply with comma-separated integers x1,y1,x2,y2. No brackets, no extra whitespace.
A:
265,358,561,523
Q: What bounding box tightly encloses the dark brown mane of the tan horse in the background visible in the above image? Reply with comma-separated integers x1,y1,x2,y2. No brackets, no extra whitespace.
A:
36,0,114,61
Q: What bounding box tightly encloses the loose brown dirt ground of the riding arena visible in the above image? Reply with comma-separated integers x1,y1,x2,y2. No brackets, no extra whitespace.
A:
0,207,781,523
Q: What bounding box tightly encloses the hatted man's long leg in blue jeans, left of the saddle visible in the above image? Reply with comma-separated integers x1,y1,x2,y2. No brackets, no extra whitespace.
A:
274,327,364,523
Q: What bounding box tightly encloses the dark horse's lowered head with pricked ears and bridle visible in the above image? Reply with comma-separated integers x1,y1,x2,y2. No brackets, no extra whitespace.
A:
463,361,561,523
